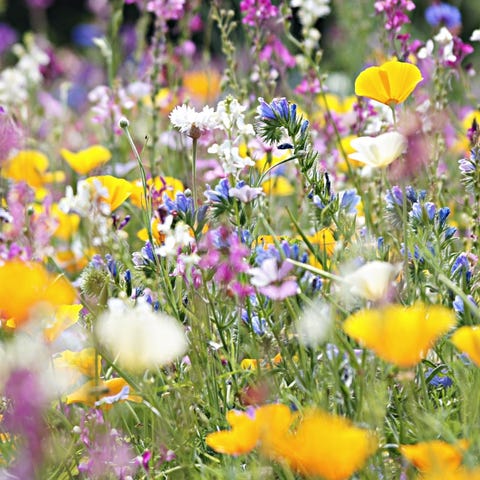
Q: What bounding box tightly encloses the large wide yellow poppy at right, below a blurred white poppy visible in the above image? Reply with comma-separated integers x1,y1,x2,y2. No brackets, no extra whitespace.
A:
343,303,456,368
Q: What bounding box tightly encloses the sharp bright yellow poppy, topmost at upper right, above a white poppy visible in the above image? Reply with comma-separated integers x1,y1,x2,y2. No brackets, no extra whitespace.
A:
355,60,423,107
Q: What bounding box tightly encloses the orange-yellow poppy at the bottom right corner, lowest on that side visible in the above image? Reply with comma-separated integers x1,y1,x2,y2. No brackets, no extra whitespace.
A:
400,439,469,472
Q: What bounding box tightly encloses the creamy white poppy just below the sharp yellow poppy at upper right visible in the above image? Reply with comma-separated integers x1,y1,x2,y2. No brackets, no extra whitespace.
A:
348,132,407,168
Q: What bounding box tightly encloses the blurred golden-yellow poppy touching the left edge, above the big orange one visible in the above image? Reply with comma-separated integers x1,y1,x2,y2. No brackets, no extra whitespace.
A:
2,150,62,189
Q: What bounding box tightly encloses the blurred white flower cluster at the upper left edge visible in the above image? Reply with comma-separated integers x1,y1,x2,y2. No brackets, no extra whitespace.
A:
0,36,50,106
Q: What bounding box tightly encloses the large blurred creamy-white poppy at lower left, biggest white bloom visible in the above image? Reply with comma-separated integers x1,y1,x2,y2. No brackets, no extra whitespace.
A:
96,299,187,372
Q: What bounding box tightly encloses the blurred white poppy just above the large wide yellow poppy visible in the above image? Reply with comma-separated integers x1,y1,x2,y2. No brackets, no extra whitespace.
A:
343,261,400,302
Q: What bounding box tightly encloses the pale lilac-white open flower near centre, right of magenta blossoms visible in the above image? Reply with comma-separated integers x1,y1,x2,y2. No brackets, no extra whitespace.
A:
248,258,298,300
